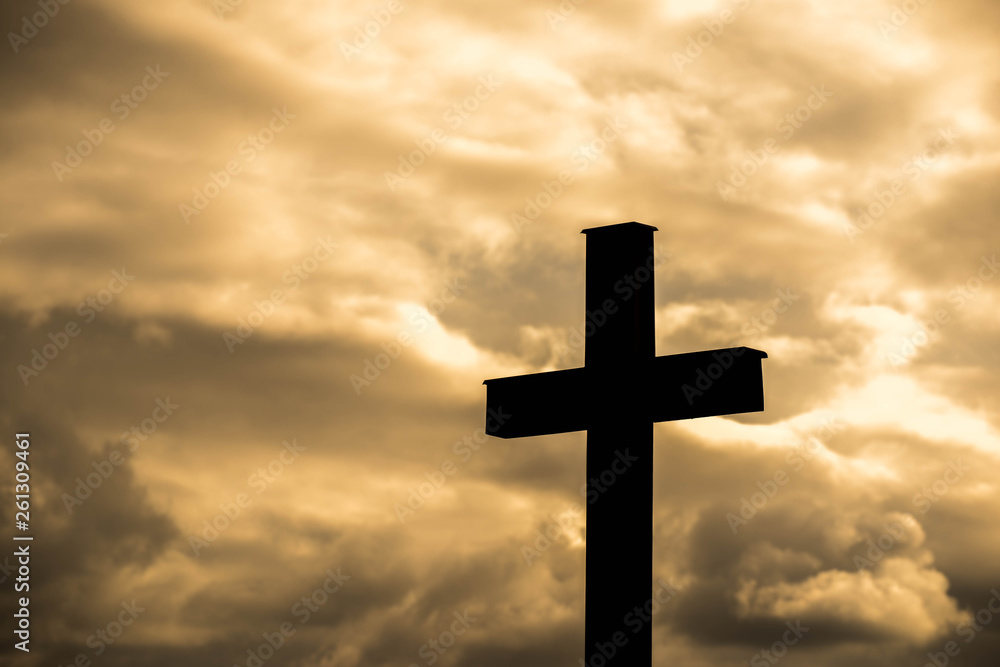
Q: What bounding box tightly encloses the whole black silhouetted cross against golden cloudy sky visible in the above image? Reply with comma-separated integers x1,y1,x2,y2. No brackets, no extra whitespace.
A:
483,222,767,667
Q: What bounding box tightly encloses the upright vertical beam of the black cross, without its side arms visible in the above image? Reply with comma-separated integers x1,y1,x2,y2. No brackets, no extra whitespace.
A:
583,224,656,667
